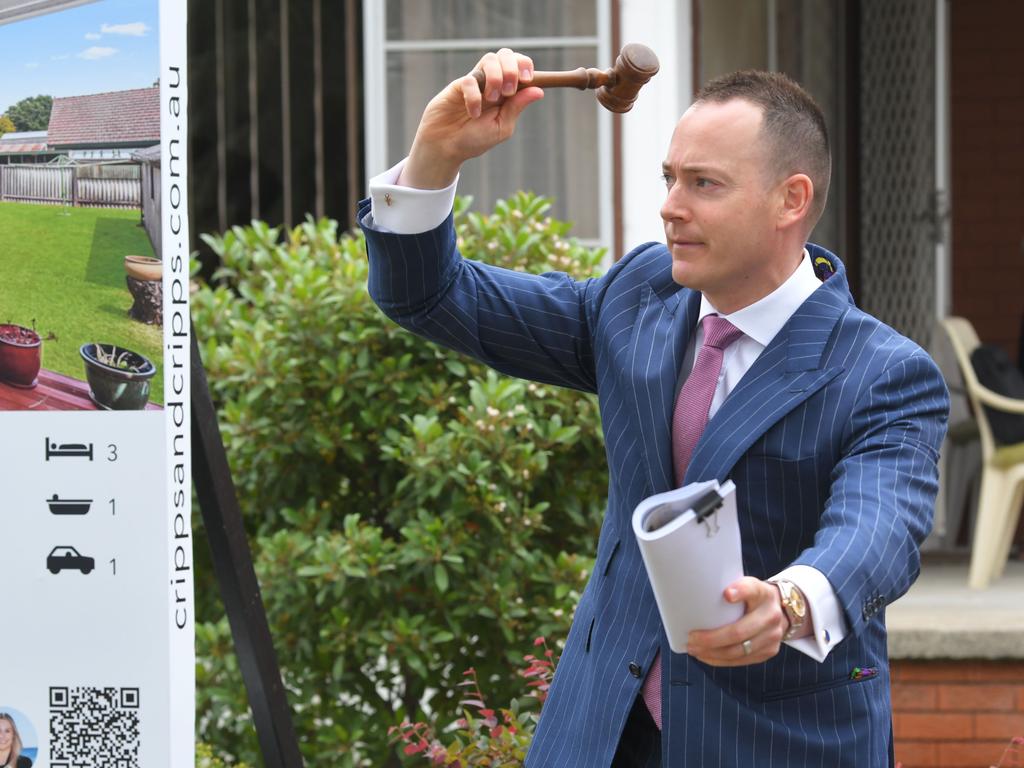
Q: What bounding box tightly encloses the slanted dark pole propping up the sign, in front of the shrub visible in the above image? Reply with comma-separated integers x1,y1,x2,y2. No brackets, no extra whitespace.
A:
191,328,302,768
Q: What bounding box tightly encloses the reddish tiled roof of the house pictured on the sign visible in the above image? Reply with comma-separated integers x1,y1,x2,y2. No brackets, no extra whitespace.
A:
48,86,160,148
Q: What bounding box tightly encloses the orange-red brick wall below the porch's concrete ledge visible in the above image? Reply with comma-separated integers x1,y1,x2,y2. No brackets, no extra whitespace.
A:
892,659,1024,768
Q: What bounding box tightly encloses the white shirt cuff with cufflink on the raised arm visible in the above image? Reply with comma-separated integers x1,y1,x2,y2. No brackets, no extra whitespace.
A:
370,158,459,234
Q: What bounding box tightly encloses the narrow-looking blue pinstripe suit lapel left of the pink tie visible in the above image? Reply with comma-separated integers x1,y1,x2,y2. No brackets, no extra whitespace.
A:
629,285,700,494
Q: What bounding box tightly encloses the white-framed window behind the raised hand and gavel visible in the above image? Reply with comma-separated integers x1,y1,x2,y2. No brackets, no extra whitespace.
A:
365,0,611,245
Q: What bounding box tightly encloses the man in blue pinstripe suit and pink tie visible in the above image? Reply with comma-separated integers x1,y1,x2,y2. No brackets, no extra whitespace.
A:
359,49,948,768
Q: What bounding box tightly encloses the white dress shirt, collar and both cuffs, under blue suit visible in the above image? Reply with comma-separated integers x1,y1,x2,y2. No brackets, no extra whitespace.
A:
370,160,847,662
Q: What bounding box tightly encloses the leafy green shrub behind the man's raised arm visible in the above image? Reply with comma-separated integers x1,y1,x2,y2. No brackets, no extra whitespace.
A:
193,194,607,768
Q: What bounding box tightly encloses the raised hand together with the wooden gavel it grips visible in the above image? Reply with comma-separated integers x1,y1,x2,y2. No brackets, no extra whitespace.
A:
398,44,658,189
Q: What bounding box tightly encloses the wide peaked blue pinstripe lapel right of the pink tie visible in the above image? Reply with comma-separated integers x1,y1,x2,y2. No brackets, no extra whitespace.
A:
688,275,849,482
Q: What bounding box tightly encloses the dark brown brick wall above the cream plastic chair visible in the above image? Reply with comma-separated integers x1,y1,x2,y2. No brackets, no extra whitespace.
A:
949,0,1024,359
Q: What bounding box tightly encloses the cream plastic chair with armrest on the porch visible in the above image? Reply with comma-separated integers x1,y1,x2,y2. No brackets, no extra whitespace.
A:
942,317,1024,589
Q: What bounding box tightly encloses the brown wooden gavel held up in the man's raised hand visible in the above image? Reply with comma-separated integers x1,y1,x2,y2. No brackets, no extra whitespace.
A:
470,43,658,113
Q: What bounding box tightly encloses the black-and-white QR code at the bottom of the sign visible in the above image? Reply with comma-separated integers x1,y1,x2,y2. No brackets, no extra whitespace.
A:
50,687,139,768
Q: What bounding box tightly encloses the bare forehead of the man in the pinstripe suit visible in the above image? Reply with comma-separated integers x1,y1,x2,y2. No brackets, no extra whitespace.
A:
668,99,762,169
